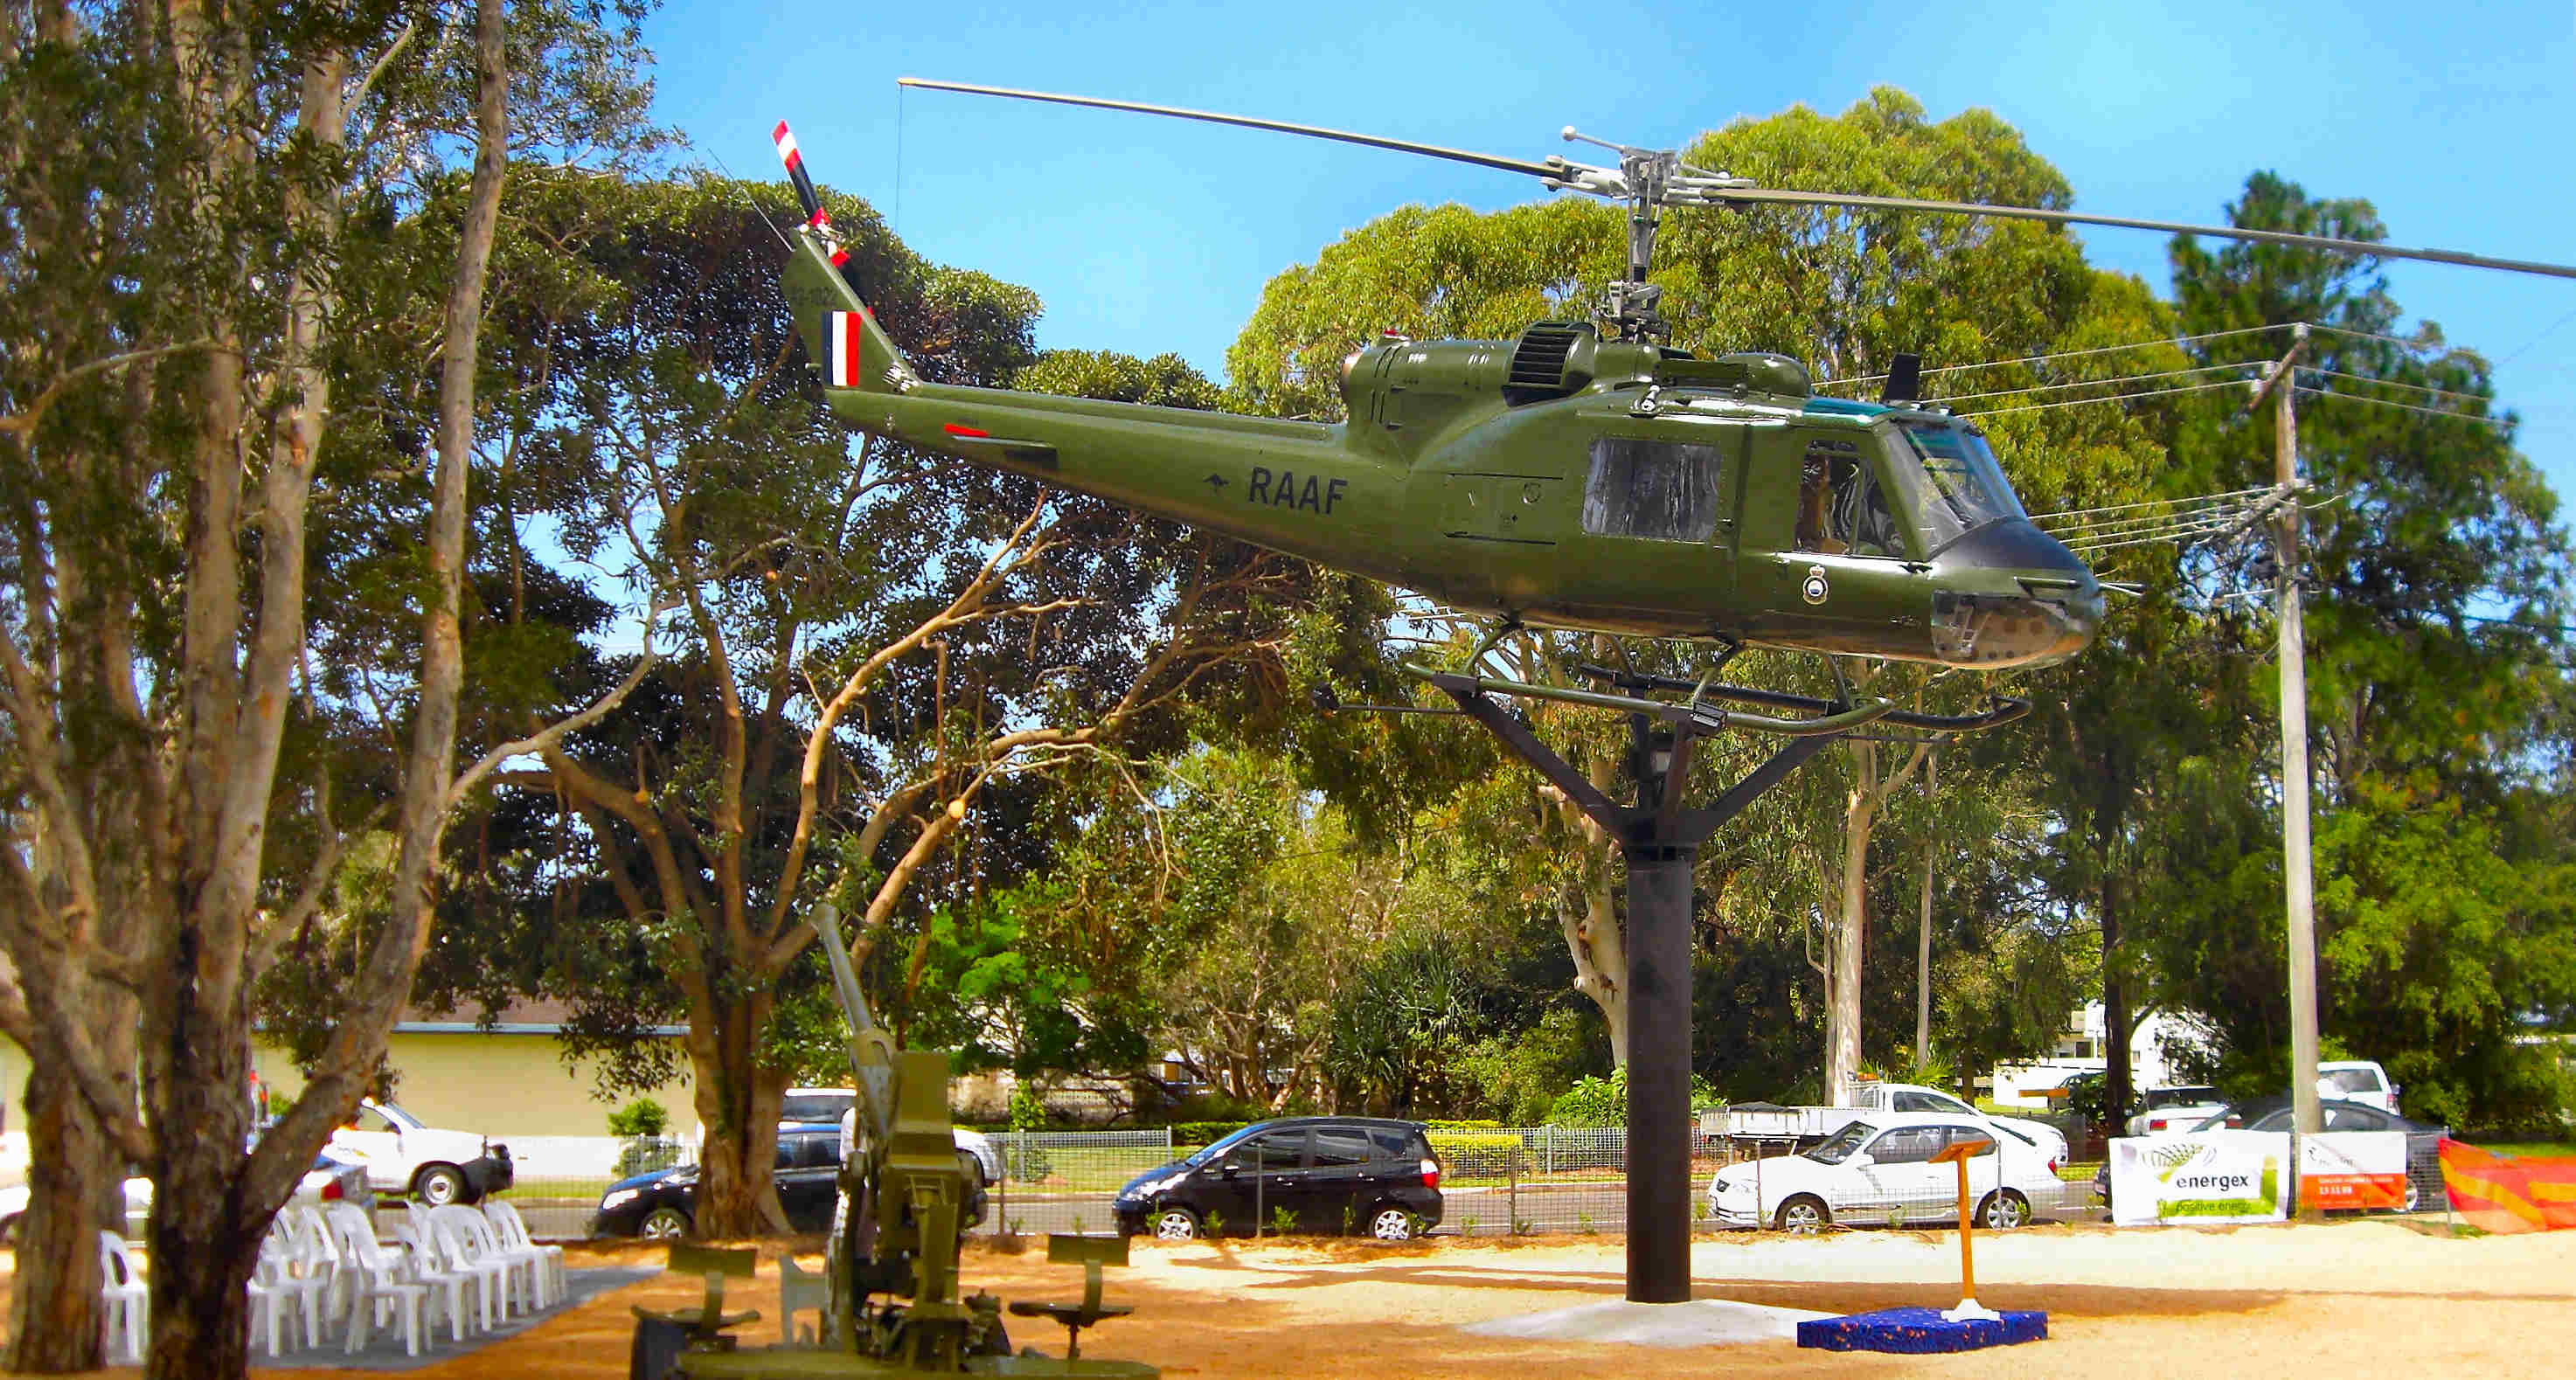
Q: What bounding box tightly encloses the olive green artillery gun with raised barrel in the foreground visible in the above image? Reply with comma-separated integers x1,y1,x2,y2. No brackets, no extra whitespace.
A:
628,906,1162,1380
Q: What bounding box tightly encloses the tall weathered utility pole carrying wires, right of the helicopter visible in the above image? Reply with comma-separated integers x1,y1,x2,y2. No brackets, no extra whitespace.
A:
2246,322,2326,1135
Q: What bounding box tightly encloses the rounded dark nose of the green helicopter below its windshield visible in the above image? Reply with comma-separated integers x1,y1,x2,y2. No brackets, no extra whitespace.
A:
1932,523,2102,669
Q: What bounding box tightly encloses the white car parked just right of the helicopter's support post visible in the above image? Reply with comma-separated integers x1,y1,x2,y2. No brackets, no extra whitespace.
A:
1708,1113,2066,1233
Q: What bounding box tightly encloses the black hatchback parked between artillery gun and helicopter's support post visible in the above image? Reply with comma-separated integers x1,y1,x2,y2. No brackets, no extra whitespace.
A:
1115,1118,1440,1241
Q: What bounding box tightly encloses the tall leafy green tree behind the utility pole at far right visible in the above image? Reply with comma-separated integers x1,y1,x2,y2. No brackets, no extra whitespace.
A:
2151,172,2576,1125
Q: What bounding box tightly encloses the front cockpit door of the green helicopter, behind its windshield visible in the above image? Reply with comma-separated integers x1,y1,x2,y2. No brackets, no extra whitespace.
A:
1744,427,1932,656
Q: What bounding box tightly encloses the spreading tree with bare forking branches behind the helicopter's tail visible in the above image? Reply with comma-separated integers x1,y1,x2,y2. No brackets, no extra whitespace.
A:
471,177,1329,1236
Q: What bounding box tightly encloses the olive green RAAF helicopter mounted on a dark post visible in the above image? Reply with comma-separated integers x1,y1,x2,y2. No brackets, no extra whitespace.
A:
775,77,2576,734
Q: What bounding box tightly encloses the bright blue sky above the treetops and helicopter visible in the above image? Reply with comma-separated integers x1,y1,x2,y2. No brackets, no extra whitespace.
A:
647,0,2576,507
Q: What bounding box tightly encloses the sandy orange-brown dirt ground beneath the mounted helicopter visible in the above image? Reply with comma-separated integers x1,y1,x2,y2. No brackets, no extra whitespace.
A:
0,1220,2576,1380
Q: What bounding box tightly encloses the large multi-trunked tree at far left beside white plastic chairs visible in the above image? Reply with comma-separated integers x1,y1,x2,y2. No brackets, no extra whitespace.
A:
0,0,654,1375
